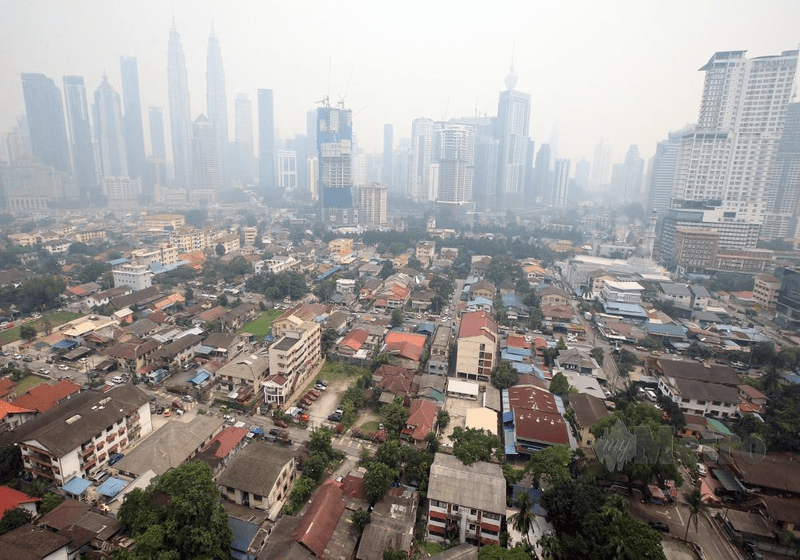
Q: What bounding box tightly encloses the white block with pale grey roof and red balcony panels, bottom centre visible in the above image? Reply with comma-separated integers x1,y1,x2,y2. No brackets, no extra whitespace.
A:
425,453,506,545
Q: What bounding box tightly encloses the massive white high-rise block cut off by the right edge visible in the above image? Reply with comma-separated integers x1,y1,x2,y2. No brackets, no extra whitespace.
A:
672,50,798,224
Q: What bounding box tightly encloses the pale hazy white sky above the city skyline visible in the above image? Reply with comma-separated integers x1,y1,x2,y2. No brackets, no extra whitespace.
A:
0,0,800,165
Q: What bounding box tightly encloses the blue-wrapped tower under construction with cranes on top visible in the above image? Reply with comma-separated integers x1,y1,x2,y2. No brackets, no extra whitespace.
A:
317,106,358,226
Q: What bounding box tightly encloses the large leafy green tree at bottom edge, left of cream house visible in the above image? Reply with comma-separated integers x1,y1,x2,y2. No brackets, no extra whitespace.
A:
114,461,233,560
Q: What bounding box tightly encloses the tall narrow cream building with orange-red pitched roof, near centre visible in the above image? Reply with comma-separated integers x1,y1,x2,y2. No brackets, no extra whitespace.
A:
455,311,499,381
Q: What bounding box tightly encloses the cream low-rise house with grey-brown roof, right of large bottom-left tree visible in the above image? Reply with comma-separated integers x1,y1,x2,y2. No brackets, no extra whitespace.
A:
217,441,297,511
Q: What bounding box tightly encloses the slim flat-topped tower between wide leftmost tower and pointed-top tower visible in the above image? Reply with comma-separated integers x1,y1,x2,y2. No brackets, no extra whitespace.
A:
64,76,97,200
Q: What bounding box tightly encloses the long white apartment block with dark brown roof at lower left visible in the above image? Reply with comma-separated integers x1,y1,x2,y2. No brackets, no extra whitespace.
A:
11,384,152,486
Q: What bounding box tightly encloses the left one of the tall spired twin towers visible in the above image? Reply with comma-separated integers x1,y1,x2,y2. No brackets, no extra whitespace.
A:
167,20,192,188
